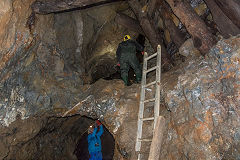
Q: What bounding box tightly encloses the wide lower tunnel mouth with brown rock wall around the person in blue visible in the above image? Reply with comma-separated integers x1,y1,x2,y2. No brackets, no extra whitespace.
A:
3,115,115,160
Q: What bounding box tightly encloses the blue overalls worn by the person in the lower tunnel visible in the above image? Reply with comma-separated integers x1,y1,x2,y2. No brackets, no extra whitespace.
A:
88,125,103,156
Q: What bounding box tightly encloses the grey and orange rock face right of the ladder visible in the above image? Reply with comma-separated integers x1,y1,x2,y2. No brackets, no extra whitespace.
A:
161,37,240,159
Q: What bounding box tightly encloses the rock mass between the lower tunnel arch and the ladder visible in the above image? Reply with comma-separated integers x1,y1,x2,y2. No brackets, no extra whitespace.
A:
63,80,140,160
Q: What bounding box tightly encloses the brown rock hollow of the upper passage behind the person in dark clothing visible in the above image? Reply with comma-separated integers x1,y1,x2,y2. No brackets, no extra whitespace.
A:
49,2,145,84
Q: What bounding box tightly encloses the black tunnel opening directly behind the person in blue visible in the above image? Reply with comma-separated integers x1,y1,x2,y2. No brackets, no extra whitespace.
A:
74,119,115,160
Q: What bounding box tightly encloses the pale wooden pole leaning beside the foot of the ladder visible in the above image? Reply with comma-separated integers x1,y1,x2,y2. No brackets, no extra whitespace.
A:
148,116,165,160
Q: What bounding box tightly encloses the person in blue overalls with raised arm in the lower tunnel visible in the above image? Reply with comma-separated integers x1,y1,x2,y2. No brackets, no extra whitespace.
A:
88,120,103,160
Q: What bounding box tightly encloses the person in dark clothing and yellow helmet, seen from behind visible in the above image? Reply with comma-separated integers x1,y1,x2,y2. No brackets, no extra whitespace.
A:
116,35,144,86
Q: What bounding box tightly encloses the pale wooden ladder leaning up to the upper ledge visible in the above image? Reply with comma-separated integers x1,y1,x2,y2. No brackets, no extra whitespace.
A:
135,45,161,160
